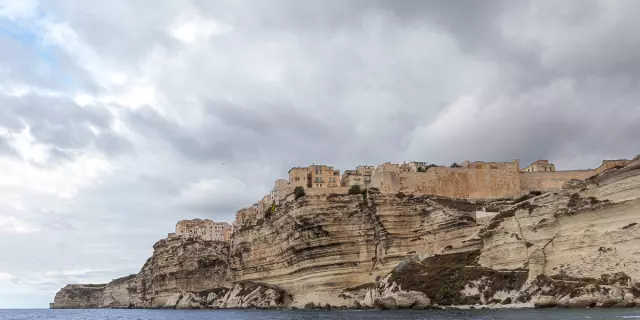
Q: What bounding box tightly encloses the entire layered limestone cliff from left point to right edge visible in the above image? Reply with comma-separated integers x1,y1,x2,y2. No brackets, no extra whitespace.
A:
52,160,640,309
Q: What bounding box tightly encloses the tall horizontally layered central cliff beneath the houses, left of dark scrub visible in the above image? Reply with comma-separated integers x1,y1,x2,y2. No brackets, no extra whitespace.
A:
230,190,480,307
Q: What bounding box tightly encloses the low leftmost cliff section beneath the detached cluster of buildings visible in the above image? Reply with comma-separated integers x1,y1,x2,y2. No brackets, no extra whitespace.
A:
53,238,230,308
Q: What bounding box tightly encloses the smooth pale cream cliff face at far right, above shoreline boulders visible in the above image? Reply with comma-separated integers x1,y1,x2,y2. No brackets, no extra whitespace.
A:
479,159,640,279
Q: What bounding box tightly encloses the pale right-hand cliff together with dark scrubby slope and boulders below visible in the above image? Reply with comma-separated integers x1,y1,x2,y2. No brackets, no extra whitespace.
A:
368,161,640,307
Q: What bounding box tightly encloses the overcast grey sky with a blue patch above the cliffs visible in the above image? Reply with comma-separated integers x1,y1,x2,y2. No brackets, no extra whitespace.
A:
0,0,640,308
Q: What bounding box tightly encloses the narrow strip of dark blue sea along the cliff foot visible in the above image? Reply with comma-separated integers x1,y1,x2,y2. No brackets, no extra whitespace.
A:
0,309,640,320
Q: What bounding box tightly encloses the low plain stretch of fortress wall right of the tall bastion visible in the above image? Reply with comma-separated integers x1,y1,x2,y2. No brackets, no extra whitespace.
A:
520,170,595,192
